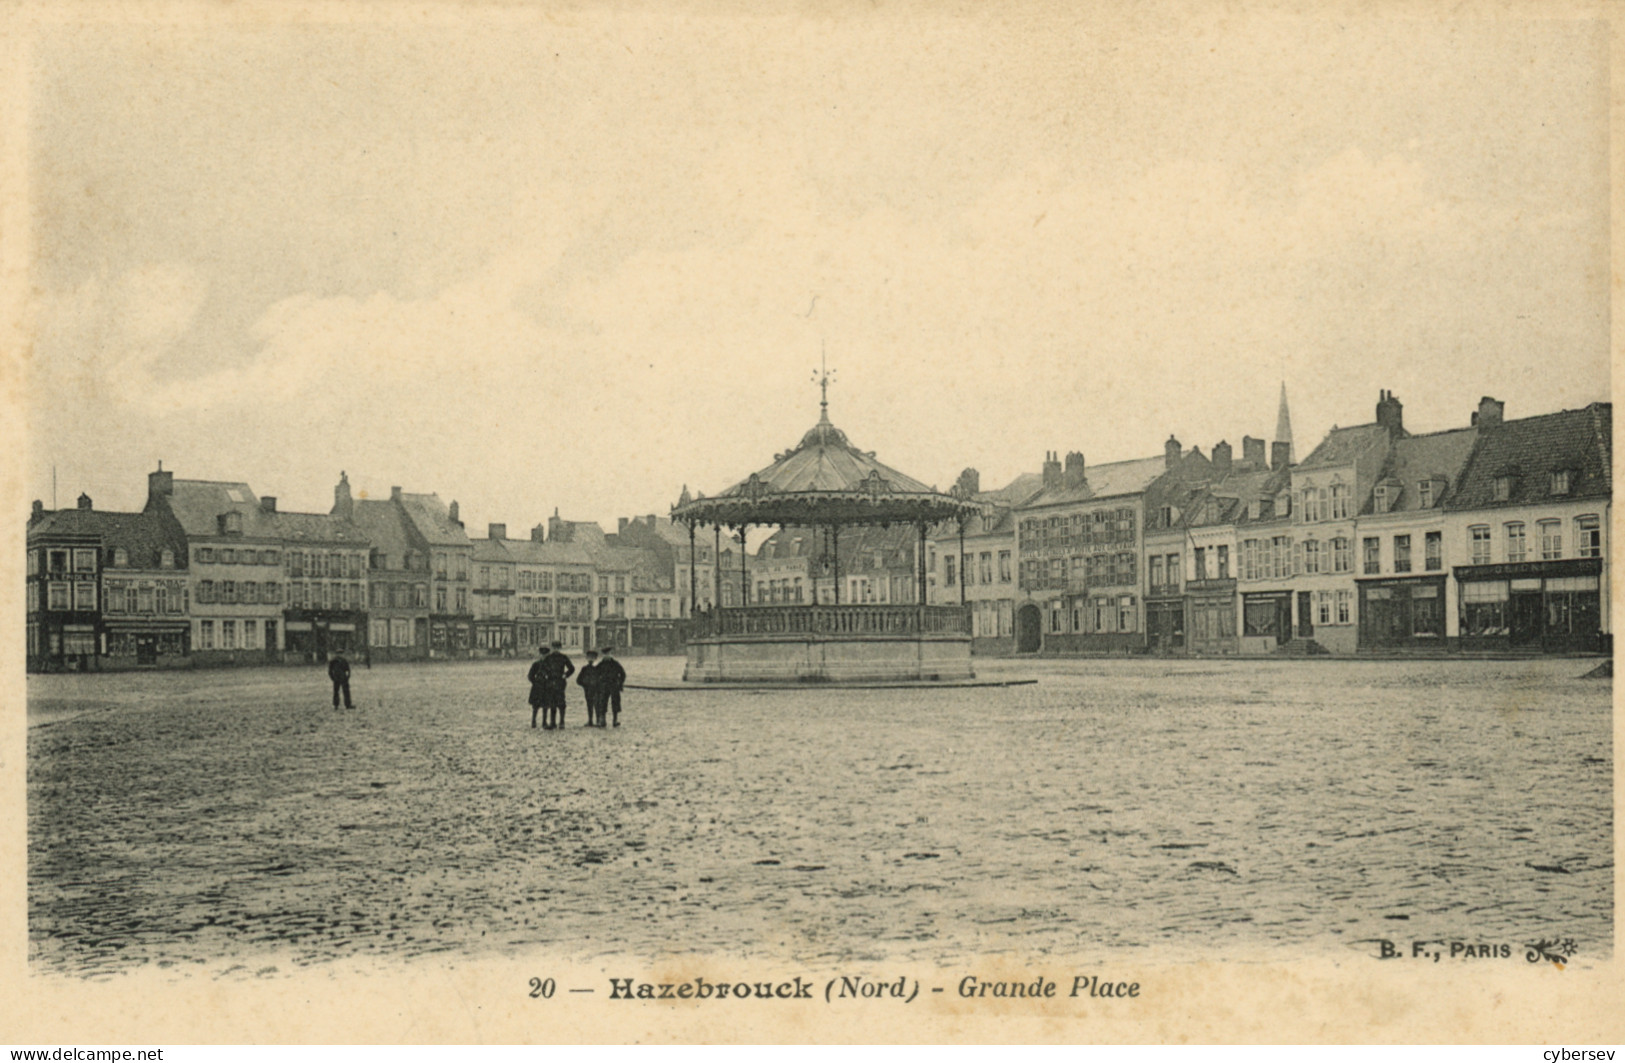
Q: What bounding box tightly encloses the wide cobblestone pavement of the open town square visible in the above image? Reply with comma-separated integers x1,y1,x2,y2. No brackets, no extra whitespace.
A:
28,658,1614,975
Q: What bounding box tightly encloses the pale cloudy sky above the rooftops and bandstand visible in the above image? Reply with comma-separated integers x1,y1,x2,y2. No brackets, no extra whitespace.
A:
26,3,1609,530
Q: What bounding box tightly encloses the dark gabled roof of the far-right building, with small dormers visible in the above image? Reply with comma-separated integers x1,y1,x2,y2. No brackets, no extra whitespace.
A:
1448,403,1614,509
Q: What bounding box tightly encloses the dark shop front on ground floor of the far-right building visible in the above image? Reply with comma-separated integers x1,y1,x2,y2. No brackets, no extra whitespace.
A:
1454,558,1610,653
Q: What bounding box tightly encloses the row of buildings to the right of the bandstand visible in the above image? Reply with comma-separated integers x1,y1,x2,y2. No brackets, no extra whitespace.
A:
930,390,1612,655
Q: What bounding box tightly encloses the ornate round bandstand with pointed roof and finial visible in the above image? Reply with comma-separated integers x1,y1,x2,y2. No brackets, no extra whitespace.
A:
671,375,978,684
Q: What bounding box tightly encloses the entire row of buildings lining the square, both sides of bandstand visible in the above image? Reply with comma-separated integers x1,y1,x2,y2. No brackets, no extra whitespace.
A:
28,390,1612,670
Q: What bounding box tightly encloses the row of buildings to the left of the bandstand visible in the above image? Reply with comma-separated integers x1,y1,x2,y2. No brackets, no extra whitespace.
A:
26,468,712,670
